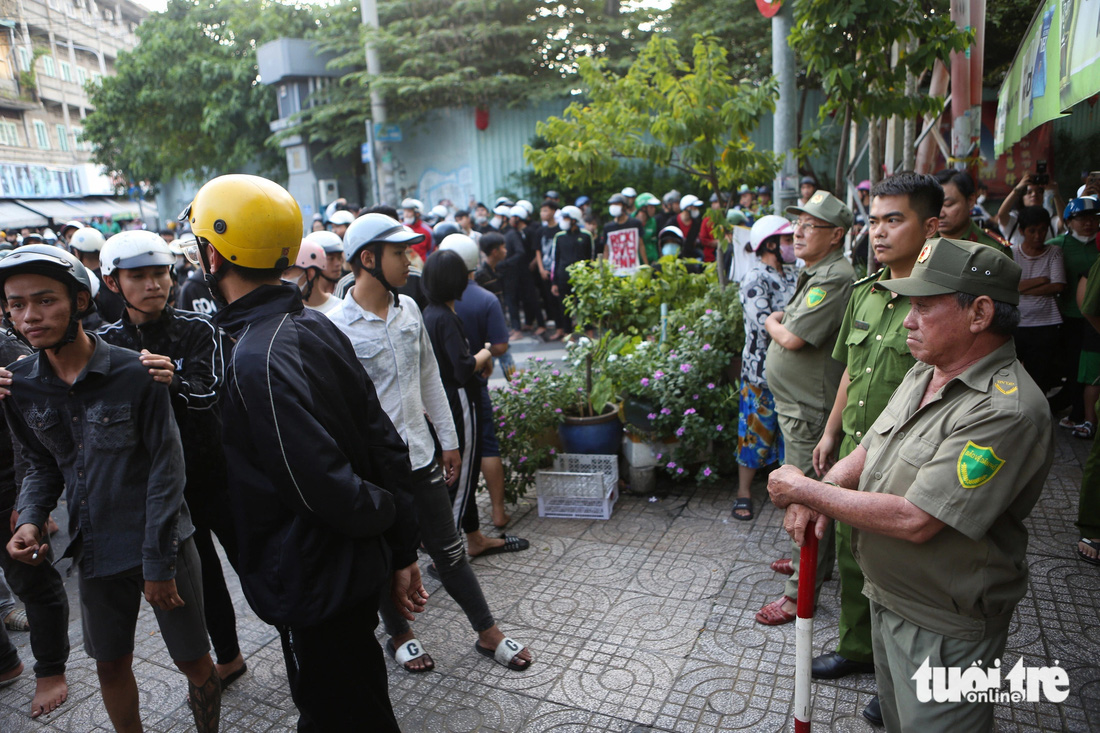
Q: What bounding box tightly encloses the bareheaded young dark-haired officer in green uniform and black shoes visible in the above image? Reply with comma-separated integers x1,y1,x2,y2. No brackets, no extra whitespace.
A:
811,172,944,724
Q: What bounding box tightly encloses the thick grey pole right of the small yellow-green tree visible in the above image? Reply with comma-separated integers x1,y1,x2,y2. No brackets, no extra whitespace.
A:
771,2,799,215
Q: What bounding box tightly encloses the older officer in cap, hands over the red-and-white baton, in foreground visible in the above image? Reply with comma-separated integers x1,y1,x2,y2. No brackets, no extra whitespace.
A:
768,239,1054,732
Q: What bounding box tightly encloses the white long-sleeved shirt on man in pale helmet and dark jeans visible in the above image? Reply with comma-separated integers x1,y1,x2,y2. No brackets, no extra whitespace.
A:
326,289,459,470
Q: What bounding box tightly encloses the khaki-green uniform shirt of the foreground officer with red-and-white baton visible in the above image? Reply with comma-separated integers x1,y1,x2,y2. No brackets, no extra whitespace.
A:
853,341,1054,641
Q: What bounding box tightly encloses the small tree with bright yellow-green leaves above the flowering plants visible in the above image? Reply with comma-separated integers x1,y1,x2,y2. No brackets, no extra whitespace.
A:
524,34,780,283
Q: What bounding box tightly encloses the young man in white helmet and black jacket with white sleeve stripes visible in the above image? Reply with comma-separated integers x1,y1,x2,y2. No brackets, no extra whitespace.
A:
98,230,244,686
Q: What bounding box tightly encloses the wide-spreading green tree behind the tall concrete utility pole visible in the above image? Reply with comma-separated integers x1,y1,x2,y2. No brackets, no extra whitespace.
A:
293,0,651,157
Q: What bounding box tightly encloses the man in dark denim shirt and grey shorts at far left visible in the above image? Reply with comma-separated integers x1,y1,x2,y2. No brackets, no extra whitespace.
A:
0,245,221,731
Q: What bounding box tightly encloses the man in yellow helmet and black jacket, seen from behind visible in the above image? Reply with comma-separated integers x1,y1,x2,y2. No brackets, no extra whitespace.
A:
183,175,427,731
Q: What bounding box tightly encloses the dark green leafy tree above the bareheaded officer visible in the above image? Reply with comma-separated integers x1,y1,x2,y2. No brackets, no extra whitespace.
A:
788,0,972,192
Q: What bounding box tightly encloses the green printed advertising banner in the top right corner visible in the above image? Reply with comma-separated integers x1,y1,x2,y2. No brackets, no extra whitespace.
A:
993,0,1100,155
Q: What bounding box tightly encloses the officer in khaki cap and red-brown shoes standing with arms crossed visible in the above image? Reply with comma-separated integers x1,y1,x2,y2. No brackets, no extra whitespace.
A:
756,190,855,626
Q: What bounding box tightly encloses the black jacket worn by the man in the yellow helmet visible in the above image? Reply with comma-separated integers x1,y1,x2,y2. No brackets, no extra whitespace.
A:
217,285,419,625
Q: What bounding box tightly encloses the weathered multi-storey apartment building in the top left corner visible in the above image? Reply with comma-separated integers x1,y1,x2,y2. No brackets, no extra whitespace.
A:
0,0,155,228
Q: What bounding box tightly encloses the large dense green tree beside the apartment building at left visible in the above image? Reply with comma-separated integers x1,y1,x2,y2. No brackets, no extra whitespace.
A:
84,0,316,185
